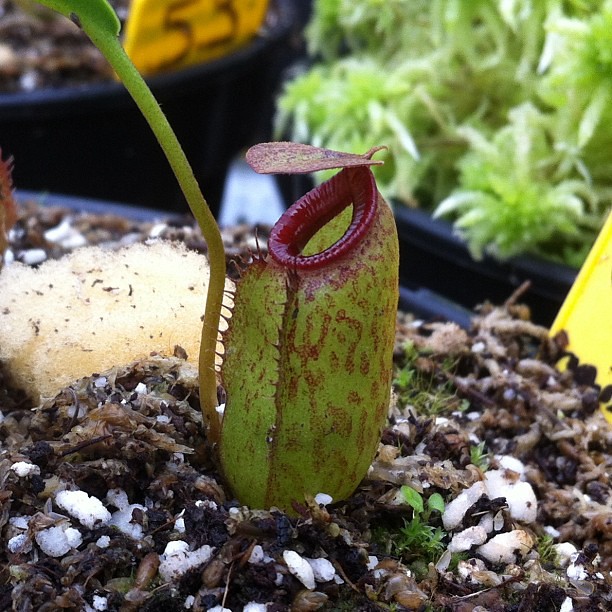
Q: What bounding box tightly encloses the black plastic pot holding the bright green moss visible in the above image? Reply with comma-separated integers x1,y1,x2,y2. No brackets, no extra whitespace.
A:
395,205,577,326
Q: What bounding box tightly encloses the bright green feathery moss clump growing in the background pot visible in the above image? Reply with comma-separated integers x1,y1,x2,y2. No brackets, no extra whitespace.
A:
277,0,612,266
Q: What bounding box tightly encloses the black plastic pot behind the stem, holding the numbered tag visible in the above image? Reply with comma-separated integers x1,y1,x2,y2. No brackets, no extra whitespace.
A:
0,0,296,212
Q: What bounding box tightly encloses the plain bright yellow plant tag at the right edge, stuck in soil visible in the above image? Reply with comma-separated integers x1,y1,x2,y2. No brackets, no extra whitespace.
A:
551,212,612,423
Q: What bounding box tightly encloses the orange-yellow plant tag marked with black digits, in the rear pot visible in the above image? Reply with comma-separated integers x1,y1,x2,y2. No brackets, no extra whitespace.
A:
123,0,268,75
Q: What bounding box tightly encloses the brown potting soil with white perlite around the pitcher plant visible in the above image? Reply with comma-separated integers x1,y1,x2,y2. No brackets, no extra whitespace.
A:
0,198,612,612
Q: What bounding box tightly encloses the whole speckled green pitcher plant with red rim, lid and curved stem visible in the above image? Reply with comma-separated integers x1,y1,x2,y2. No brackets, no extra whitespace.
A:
32,0,399,510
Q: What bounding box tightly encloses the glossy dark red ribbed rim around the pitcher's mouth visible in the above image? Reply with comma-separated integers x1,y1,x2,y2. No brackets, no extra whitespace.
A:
268,167,378,270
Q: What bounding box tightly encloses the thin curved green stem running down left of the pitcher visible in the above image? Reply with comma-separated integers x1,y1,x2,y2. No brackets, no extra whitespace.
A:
83,24,225,444
